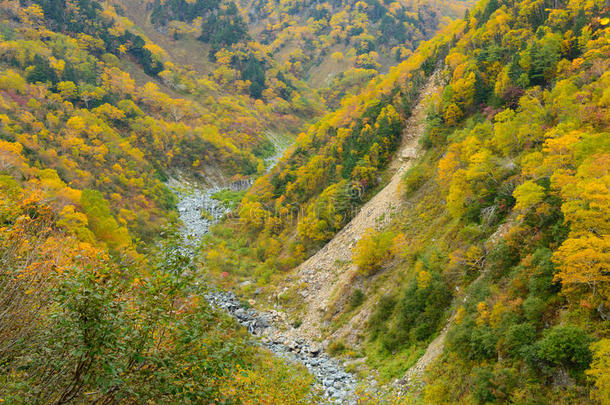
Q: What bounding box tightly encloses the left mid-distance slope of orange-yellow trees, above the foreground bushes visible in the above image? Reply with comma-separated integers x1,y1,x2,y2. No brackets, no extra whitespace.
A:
2,1,314,243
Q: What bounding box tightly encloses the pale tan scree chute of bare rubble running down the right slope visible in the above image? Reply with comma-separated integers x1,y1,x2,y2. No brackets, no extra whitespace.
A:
282,74,439,339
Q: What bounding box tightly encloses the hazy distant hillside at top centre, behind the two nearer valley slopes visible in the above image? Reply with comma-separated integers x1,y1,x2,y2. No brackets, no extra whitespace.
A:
123,0,472,108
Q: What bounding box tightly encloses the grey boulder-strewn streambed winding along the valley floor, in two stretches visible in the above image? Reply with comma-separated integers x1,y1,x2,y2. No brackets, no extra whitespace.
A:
168,179,356,404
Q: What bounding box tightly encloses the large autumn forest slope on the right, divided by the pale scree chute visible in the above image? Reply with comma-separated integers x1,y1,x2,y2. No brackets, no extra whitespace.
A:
201,0,610,403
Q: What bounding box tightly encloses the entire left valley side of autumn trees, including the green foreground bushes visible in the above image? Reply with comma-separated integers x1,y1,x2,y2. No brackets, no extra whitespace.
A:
0,0,324,404
